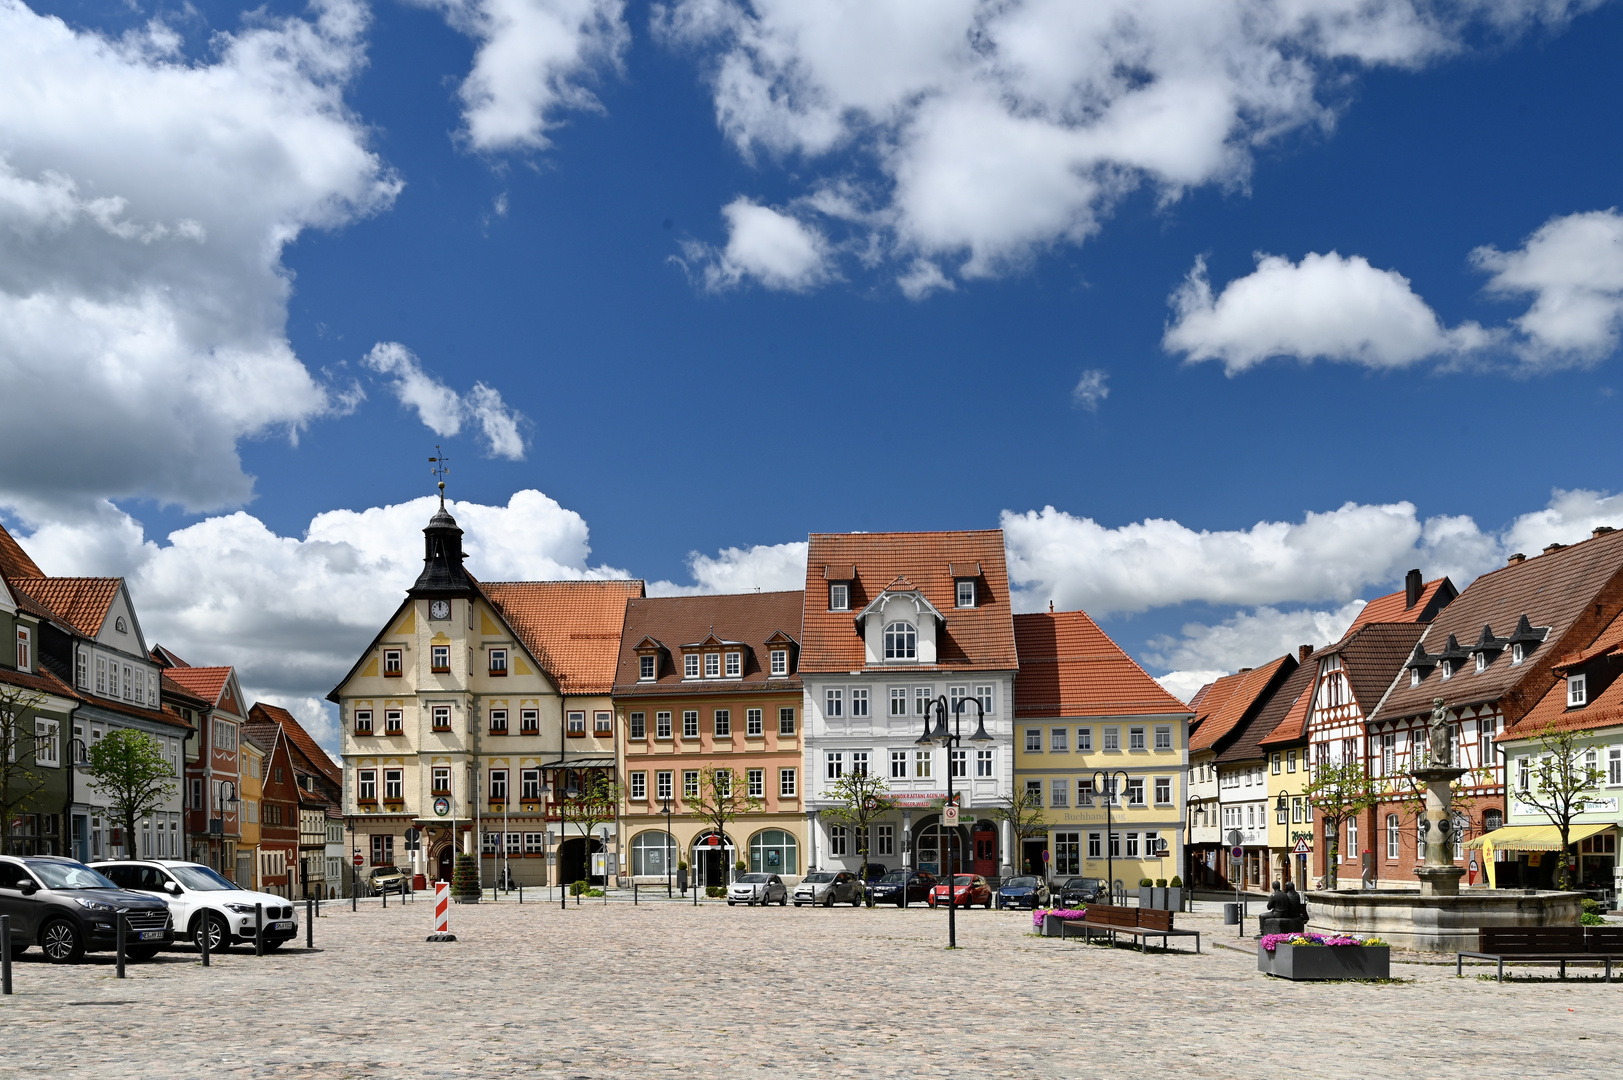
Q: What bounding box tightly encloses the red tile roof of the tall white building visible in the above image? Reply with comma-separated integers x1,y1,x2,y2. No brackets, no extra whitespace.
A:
800,529,1019,672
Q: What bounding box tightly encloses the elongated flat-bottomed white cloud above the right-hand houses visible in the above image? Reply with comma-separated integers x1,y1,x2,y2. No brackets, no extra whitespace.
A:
1162,252,1492,375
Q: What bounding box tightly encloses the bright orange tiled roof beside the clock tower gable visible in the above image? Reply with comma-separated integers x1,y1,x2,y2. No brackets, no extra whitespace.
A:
479,578,646,693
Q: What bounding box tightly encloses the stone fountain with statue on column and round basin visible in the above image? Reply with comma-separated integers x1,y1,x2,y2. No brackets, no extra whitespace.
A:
1308,698,1582,952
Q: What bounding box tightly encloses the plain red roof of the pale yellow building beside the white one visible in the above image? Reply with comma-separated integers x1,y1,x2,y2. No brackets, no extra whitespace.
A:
1014,611,1190,718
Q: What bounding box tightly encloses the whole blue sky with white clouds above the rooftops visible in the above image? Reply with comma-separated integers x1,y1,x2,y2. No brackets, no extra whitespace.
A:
0,0,1623,745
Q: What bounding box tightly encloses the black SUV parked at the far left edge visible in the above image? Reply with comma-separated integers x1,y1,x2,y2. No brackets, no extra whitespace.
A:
0,856,175,963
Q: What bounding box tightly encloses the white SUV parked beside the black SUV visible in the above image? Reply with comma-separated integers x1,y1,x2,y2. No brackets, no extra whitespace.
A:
93,859,299,952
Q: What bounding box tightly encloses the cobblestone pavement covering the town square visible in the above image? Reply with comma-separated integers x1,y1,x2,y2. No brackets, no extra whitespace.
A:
0,901,1623,1080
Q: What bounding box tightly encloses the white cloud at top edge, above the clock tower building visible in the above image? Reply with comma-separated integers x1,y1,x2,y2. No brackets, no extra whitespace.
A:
419,0,631,151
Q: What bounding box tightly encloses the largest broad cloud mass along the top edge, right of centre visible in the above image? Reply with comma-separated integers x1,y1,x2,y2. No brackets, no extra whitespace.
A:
654,0,1595,285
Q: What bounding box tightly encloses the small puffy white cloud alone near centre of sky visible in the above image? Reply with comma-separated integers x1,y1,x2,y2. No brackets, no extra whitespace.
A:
685,197,829,292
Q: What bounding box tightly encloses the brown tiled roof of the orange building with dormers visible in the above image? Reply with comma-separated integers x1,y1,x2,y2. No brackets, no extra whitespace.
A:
613,590,803,697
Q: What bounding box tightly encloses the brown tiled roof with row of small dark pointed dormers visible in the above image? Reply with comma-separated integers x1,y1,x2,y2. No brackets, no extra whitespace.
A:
1370,533,1623,721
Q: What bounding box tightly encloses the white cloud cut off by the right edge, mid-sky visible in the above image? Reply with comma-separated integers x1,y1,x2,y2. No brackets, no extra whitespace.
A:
1470,210,1623,367
